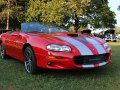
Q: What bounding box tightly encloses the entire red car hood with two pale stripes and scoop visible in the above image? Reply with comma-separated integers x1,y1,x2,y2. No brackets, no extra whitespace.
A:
27,32,109,55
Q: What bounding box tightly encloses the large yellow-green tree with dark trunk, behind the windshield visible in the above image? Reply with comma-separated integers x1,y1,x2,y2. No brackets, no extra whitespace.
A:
26,0,91,32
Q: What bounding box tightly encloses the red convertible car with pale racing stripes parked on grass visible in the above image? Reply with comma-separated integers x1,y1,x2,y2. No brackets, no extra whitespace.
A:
0,22,111,74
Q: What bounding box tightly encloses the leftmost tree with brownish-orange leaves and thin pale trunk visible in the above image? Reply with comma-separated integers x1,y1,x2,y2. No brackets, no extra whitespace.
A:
0,0,21,30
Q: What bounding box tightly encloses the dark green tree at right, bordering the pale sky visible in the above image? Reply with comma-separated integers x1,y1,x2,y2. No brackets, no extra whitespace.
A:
85,0,116,28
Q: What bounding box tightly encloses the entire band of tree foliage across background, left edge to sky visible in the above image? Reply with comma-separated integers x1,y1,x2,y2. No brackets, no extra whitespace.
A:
0,0,116,32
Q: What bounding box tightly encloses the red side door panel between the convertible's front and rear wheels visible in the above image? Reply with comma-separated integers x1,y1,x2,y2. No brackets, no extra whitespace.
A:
6,32,24,59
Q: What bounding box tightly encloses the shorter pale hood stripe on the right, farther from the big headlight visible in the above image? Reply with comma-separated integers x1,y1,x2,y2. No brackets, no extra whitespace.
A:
86,37,106,54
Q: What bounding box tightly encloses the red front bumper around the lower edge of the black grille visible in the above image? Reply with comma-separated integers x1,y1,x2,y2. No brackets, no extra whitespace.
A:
37,53,111,69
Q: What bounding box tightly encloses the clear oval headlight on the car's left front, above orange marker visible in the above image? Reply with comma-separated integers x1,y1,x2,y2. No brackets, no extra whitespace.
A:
47,44,71,52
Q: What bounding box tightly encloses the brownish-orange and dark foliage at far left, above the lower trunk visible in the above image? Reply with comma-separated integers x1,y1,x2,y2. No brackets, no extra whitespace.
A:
0,0,28,27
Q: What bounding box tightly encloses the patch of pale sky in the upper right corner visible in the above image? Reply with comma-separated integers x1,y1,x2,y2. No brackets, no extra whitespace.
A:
108,0,120,27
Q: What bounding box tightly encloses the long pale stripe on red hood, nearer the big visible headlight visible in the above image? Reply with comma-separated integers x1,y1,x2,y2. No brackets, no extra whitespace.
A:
57,36,93,55
